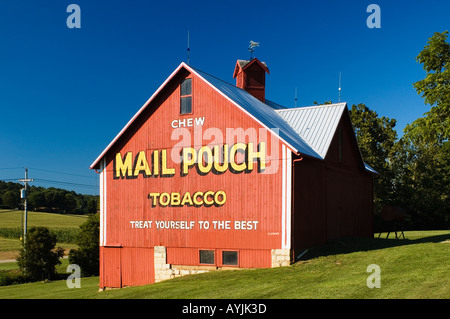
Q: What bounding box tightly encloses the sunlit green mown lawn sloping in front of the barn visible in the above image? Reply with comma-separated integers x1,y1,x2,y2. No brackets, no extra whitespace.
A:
0,231,450,299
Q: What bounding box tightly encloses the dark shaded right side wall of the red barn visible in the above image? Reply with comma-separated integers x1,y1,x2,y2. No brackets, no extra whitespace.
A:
292,113,373,250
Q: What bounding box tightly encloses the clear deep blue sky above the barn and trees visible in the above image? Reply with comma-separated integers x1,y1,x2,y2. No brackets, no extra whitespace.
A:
0,0,450,194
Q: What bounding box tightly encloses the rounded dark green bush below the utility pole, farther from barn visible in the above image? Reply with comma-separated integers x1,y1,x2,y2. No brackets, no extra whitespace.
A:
17,227,64,280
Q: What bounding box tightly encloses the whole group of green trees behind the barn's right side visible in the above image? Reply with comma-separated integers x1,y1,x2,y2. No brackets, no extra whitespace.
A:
350,31,450,229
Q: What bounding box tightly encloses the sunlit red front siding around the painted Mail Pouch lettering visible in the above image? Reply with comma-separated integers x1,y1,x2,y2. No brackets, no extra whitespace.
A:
104,69,282,255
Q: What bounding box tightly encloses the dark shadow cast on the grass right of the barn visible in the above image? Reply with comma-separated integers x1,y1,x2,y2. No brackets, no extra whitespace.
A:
296,234,450,262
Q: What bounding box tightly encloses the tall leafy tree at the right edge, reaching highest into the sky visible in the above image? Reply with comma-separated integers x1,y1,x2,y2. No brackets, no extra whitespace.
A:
394,31,450,229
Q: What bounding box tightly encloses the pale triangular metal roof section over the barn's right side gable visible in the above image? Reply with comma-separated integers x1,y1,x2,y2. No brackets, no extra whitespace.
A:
275,103,346,159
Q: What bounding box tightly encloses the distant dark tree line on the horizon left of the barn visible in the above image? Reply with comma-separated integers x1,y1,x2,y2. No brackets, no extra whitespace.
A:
0,181,99,214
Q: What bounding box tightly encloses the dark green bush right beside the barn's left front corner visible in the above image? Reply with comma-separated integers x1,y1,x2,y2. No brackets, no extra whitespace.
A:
69,213,100,276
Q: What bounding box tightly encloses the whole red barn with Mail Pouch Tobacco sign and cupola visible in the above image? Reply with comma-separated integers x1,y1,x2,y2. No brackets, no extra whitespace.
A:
91,58,373,288
